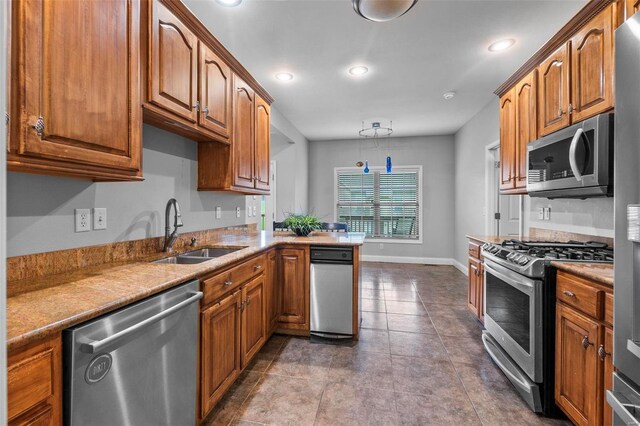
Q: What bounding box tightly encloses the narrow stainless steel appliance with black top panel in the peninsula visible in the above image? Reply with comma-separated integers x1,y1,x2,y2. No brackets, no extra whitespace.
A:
310,246,353,339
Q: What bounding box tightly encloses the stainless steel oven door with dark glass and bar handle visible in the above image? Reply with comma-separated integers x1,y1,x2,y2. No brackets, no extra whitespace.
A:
484,258,542,383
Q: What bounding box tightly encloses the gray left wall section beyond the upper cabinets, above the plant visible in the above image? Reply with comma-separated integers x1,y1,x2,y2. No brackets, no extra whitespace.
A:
271,107,309,221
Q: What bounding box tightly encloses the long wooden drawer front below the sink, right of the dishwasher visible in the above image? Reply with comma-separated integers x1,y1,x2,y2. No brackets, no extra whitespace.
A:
202,255,267,306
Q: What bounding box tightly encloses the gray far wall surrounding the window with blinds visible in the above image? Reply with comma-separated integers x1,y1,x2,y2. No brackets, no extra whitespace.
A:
309,136,454,261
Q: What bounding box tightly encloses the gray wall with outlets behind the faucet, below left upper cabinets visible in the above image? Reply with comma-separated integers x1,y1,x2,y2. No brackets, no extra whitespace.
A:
7,125,254,256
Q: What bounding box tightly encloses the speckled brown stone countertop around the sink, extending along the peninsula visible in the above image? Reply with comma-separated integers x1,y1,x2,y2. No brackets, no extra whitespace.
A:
7,231,365,350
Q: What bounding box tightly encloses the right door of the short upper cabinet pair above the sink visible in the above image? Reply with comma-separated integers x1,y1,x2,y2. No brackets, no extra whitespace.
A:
198,42,233,139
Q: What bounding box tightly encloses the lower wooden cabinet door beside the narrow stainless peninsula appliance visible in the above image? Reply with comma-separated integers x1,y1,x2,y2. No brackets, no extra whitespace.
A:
278,248,309,329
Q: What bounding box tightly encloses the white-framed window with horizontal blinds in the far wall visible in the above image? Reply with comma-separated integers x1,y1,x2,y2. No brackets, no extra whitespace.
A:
335,166,422,241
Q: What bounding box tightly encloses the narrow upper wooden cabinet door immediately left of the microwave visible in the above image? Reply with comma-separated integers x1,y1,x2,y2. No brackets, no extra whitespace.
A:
514,70,538,189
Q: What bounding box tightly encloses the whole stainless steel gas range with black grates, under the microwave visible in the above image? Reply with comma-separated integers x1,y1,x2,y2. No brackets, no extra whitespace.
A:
482,240,613,417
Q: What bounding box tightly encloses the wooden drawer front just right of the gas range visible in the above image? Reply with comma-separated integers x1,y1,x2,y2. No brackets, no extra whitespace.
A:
556,272,604,319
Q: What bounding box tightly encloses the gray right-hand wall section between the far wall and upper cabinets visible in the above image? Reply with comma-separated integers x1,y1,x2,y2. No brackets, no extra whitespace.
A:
454,98,500,267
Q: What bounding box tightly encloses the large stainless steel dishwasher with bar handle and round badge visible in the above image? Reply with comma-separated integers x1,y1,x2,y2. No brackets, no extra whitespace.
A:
63,281,202,426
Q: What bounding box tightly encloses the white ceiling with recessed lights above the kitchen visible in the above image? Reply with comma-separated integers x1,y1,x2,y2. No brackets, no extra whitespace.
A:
183,0,586,140
